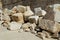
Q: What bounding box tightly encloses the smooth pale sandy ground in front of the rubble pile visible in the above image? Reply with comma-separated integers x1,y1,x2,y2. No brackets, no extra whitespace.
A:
0,28,41,40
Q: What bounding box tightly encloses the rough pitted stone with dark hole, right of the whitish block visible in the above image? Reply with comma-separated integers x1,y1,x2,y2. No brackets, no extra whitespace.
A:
22,23,36,33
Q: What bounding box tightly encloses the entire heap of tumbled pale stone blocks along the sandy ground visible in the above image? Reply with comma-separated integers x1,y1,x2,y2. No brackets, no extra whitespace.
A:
0,5,60,40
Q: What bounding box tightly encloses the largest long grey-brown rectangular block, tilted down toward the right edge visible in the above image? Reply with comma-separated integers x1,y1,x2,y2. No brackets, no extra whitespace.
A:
39,18,60,33
